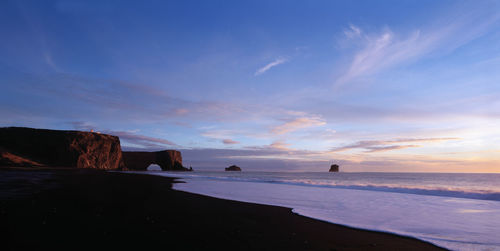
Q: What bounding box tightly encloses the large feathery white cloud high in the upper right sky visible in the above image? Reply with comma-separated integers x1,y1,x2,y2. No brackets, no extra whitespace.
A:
336,8,499,85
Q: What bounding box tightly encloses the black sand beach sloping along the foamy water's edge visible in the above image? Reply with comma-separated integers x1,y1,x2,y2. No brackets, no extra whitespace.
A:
0,169,446,250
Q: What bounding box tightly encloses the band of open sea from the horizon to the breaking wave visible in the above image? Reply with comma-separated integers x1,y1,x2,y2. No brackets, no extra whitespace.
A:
156,172,500,201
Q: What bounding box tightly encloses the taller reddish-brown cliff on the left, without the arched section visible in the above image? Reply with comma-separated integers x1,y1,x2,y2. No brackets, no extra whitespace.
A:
0,127,124,170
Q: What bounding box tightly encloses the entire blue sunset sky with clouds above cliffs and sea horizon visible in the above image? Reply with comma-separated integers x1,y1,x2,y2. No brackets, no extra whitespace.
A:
0,0,500,172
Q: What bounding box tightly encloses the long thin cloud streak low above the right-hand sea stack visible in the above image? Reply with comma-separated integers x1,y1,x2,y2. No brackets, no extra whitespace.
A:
331,138,460,153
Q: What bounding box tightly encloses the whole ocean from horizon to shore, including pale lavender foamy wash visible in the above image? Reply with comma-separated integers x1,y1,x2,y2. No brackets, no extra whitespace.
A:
145,171,500,250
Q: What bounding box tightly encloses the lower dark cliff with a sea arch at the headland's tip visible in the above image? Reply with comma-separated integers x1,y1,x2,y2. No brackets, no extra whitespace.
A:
123,150,193,171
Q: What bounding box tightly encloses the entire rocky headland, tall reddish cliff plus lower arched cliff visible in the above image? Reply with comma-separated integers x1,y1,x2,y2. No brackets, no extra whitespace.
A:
0,127,192,171
